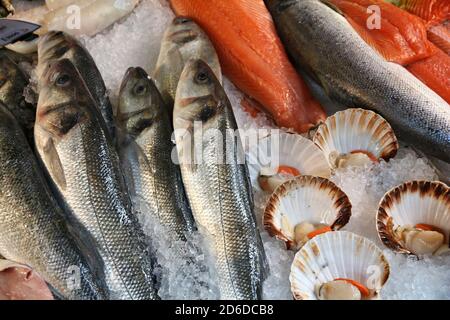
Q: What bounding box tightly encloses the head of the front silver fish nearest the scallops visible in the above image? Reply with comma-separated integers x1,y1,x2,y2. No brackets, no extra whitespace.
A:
173,59,227,130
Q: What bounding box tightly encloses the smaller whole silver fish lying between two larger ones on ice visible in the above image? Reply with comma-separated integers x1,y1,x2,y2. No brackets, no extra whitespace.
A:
117,68,194,240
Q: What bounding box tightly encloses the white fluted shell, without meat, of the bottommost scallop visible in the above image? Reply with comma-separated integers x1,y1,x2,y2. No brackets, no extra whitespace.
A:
289,231,389,300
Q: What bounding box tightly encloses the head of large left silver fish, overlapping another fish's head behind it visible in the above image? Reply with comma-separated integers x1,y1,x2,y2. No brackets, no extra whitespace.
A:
35,59,96,138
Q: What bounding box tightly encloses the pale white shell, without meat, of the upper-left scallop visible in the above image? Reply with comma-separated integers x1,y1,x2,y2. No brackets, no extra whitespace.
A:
248,131,331,190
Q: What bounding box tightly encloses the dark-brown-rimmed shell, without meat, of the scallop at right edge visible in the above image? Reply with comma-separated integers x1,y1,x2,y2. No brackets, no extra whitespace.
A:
377,181,450,254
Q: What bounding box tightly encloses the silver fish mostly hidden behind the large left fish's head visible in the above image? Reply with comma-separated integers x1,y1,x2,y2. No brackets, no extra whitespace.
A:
38,31,115,138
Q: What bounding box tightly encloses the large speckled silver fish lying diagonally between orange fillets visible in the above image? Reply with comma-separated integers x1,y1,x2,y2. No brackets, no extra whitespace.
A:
265,0,450,162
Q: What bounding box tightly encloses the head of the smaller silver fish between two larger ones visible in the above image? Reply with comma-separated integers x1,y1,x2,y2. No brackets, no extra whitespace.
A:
117,67,166,137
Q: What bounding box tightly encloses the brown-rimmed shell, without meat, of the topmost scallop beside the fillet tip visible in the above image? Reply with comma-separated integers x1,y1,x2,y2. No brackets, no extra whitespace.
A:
313,108,398,168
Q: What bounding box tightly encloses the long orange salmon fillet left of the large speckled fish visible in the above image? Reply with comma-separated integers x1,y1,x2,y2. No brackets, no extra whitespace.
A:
170,0,326,132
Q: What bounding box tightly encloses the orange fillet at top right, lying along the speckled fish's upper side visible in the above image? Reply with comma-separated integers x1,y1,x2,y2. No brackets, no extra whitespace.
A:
330,0,433,65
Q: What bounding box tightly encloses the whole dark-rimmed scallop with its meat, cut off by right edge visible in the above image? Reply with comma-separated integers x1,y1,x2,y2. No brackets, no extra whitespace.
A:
377,181,450,255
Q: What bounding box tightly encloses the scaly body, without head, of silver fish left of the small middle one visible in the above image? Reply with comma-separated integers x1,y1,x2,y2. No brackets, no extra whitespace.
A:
56,121,157,299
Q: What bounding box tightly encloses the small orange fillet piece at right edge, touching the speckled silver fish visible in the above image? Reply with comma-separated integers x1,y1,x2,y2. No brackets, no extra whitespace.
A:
406,44,450,103
